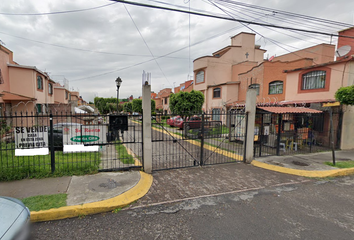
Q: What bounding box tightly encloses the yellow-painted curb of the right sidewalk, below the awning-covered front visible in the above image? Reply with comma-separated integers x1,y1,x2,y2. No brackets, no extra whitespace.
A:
251,160,354,178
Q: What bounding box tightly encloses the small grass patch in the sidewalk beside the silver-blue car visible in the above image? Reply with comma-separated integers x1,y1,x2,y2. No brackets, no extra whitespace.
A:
21,193,67,211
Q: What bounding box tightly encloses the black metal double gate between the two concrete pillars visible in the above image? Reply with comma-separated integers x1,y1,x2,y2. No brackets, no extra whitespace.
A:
152,111,244,170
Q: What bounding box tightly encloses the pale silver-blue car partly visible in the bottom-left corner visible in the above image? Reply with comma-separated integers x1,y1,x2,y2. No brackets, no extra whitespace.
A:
0,196,31,240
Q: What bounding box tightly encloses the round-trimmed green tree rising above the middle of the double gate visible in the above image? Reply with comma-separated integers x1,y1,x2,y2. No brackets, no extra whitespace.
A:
170,90,204,116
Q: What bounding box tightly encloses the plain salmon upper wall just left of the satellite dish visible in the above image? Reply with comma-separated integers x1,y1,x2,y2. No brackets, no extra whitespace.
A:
273,43,335,64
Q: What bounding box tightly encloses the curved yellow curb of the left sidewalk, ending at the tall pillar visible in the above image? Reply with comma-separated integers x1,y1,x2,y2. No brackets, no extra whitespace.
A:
31,172,153,222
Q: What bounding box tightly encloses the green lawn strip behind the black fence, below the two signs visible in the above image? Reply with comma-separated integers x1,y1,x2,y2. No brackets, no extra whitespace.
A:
0,143,101,181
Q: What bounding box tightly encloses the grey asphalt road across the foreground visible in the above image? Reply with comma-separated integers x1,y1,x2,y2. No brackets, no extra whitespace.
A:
29,176,354,240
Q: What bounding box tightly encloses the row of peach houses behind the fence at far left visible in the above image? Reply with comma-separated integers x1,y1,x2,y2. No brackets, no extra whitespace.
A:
0,45,84,116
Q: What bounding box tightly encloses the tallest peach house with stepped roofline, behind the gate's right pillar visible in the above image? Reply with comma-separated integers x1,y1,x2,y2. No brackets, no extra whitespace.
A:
193,32,266,113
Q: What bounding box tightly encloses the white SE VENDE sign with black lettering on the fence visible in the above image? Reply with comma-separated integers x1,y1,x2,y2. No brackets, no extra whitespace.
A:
14,126,49,156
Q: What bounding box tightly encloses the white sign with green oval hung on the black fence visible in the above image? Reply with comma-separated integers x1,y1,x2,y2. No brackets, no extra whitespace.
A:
63,125,108,153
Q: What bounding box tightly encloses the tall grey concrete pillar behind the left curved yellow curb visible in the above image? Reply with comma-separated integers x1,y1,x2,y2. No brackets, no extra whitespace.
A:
143,84,152,173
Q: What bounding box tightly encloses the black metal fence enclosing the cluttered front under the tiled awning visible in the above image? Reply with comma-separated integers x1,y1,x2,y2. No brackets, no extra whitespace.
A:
254,112,341,157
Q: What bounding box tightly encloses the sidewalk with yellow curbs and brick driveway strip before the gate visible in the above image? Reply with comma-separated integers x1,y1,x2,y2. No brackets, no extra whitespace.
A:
0,150,354,222
